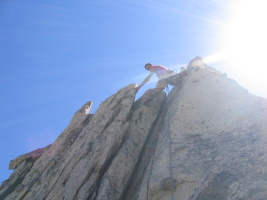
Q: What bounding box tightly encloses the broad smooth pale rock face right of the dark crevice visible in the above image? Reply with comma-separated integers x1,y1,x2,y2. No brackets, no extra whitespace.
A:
135,58,267,200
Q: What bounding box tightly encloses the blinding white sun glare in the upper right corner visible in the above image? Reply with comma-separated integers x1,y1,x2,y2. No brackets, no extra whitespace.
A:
208,0,267,98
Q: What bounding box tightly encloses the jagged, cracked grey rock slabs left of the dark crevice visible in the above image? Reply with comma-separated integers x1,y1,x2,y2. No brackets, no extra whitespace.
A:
0,84,165,199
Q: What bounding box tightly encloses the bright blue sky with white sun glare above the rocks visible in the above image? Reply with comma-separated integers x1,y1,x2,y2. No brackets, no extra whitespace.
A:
0,0,267,183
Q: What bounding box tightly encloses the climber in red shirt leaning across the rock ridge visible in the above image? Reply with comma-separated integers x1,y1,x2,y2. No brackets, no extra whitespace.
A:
136,63,186,96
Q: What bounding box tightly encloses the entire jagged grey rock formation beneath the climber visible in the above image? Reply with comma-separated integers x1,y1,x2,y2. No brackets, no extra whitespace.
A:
0,57,267,200
